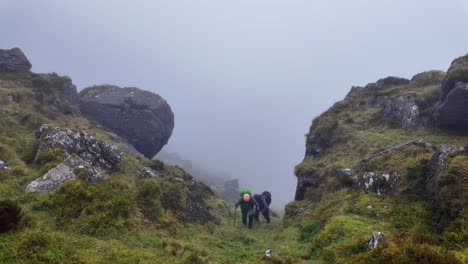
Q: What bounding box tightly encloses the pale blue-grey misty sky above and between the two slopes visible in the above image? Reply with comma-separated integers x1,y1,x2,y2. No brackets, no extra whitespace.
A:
0,0,468,207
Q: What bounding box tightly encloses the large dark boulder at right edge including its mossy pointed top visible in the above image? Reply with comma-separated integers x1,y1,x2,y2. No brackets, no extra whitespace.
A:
434,55,468,128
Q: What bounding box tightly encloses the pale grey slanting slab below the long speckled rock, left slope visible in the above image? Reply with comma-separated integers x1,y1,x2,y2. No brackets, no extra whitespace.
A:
26,155,102,192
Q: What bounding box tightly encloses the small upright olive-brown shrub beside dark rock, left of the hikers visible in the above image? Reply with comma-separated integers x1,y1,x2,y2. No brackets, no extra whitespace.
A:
136,179,162,221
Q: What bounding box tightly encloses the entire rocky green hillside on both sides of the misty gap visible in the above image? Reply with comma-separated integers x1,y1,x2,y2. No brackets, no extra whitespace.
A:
0,49,468,263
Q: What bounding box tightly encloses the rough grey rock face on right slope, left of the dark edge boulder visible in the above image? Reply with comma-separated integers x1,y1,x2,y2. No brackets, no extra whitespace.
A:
384,95,421,129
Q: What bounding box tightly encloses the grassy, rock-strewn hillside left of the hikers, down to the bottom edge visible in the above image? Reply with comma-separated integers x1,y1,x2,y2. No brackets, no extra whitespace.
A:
0,49,307,263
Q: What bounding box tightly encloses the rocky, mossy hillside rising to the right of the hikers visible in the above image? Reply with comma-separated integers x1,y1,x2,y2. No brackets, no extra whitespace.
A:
290,56,468,263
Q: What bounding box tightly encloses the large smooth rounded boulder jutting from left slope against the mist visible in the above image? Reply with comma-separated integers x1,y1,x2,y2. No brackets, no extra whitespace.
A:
80,85,174,158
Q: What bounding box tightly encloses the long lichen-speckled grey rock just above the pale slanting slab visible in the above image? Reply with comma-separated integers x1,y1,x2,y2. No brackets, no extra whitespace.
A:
36,125,123,170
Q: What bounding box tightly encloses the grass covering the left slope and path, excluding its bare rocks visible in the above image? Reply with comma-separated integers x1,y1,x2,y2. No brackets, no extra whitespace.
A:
0,70,308,263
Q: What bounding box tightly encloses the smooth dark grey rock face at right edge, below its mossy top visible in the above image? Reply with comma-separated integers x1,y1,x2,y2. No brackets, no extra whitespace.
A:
434,82,468,128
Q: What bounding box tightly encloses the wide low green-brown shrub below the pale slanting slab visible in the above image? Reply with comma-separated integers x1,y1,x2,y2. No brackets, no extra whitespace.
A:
44,180,135,235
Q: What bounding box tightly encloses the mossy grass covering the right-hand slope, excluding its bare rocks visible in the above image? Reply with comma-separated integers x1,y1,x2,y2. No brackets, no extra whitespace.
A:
286,71,468,263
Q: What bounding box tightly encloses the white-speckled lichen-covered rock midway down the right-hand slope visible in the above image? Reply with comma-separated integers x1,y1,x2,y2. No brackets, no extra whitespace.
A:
354,172,400,195
